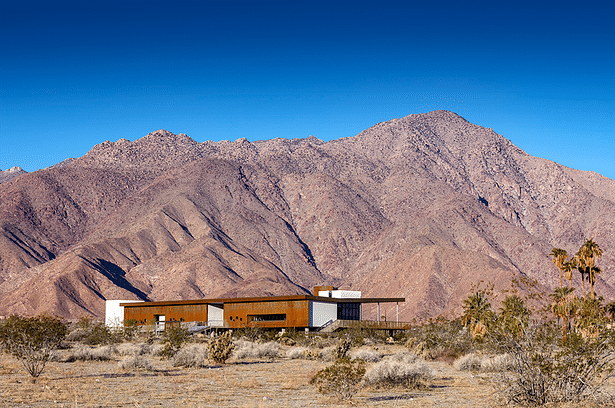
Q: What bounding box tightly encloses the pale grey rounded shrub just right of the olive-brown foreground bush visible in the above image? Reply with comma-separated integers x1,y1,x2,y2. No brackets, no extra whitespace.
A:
365,351,432,388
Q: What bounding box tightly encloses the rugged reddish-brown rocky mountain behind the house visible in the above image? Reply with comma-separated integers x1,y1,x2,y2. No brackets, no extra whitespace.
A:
0,111,615,319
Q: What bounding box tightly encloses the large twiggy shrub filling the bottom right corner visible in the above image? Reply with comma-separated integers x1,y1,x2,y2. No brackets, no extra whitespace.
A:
494,321,615,405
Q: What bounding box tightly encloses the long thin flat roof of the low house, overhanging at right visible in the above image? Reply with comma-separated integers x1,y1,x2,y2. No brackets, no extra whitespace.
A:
120,295,406,307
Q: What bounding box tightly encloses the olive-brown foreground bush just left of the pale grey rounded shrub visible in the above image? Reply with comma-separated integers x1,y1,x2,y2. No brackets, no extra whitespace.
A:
310,358,365,400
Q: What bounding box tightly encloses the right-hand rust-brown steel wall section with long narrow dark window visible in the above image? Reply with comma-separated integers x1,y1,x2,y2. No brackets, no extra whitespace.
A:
224,300,310,329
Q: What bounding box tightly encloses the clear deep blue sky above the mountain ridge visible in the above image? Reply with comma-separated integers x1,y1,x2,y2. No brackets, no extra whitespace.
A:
0,0,615,179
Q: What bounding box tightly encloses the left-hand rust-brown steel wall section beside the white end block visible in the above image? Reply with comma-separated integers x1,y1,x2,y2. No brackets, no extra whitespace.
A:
124,303,207,324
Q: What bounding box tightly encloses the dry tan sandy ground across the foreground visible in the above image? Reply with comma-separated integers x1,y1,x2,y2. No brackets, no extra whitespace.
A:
0,344,612,408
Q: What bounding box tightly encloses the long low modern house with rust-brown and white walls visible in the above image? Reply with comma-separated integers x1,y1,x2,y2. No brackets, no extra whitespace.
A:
106,286,410,331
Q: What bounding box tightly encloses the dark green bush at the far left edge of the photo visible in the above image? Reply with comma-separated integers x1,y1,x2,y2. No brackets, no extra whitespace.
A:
0,315,68,378
